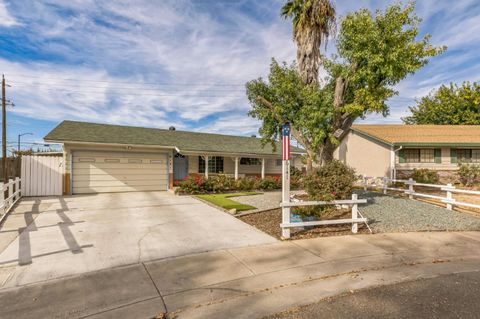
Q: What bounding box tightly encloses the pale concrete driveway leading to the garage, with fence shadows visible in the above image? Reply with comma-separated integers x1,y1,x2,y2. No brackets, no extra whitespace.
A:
0,192,276,288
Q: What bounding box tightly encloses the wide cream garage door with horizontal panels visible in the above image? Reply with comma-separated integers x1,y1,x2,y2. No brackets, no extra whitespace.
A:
72,151,168,194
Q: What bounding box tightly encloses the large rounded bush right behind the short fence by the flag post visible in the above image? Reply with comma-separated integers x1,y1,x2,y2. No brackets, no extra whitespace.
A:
303,160,357,201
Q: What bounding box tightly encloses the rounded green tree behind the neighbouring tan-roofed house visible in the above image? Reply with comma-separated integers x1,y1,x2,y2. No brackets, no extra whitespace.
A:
402,82,480,125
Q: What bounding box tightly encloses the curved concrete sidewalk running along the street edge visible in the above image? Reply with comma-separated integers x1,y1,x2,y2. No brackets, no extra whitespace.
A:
0,232,480,318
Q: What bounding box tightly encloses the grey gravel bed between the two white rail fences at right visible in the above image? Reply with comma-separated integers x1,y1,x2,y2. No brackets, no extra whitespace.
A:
356,191,480,233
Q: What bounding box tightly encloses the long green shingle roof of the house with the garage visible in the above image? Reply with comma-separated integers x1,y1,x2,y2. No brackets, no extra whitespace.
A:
44,121,304,155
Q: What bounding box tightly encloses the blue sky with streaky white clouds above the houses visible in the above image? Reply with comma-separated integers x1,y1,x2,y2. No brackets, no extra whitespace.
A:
0,0,480,152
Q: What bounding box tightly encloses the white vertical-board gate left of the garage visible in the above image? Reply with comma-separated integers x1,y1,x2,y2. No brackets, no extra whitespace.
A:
21,156,63,196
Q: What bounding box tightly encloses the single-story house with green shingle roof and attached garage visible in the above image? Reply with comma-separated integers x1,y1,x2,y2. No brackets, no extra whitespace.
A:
44,121,304,194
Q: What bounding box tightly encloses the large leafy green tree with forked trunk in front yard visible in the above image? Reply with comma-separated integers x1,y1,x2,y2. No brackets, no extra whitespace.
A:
247,3,444,169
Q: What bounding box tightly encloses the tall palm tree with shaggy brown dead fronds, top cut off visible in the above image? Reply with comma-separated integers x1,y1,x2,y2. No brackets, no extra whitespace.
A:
281,0,335,85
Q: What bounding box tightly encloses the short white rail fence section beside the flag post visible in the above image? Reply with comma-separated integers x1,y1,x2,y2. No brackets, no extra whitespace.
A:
280,194,367,238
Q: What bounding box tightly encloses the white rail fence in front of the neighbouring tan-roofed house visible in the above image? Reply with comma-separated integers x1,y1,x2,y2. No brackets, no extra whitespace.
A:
363,176,480,210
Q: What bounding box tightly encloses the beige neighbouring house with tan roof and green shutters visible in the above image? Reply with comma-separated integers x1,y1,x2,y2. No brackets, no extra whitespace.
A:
335,125,480,178
